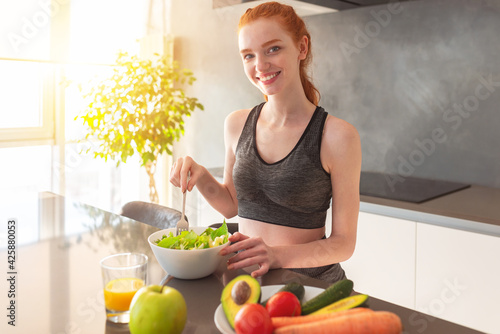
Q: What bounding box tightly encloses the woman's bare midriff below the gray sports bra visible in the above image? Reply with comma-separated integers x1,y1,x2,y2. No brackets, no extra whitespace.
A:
238,217,325,246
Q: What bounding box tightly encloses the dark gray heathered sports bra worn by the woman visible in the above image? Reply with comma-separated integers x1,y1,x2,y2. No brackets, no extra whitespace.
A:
233,103,332,229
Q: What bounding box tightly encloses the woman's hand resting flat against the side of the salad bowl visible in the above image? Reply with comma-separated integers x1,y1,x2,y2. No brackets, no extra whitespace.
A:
220,232,275,277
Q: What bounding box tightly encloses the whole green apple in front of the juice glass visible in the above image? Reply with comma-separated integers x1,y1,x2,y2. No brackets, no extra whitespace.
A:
129,285,187,334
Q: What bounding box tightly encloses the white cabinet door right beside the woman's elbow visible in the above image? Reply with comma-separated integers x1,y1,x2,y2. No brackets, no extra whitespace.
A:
342,212,416,308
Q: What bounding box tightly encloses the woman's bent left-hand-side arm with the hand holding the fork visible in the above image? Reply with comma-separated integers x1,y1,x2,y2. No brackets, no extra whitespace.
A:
170,110,248,218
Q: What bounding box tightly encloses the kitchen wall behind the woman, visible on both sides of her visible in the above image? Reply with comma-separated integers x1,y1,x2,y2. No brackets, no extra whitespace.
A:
171,0,500,188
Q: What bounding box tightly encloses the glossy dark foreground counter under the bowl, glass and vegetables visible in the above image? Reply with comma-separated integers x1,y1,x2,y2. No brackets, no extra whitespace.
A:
0,193,480,334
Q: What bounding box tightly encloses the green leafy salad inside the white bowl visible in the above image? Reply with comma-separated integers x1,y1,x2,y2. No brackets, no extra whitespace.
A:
155,220,229,249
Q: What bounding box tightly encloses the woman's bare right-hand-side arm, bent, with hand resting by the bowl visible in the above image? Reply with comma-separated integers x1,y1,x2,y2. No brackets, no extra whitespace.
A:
222,117,361,276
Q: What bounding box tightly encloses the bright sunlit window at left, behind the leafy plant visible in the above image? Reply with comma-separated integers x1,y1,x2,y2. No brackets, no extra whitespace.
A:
0,0,160,211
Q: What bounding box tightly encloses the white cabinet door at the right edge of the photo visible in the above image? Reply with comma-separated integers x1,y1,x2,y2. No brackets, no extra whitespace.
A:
416,224,500,333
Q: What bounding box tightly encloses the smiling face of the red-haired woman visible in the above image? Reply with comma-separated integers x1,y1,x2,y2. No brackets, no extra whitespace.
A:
238,18,308,96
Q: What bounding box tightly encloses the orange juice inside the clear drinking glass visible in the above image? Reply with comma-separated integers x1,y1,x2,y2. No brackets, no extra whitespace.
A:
104,278,144,311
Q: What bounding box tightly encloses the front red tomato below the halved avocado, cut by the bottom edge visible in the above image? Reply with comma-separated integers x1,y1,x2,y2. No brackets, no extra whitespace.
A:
234,303,273,334
